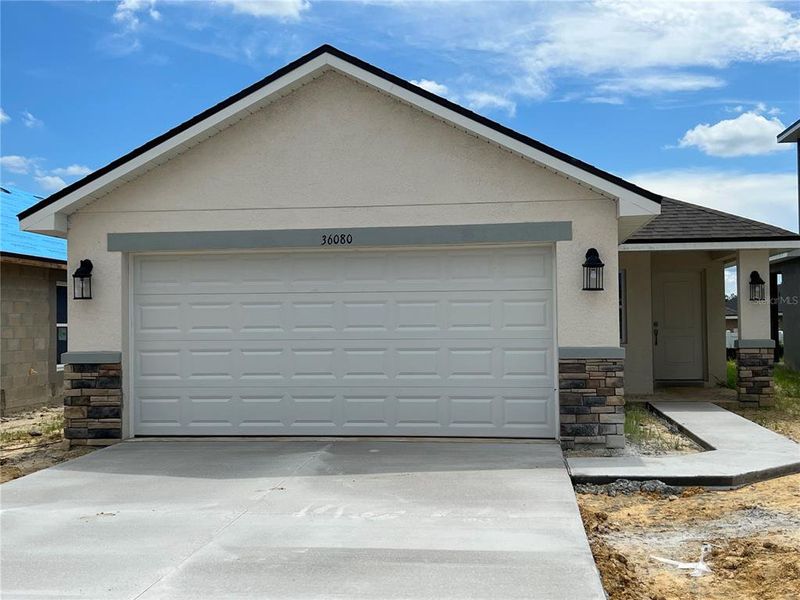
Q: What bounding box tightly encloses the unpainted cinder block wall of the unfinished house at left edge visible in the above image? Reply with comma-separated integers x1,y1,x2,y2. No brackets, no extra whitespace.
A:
0,261,66,414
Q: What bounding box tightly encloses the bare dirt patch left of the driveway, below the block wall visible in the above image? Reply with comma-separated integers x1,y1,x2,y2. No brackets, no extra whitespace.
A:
0,408,93,483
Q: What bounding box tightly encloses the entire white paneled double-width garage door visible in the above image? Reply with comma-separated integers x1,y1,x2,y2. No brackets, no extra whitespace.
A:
133,247,555,438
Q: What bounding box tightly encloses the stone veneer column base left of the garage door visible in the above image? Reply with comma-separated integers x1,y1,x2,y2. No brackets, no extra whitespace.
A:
64,363,122,446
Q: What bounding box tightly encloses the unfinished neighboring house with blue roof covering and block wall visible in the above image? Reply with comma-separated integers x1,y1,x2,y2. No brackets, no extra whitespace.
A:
0,184,67,415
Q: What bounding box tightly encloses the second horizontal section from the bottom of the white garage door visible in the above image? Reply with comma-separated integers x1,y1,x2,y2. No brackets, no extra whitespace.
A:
135,339,554,388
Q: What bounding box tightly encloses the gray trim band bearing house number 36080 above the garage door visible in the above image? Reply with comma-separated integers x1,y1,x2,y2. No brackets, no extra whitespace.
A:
108,221,572,252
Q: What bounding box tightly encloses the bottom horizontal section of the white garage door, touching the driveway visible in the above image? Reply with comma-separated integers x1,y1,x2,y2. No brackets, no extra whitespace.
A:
137,387,553,437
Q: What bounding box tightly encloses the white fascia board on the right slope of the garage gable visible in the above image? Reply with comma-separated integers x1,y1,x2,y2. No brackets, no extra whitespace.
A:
327,55,661,216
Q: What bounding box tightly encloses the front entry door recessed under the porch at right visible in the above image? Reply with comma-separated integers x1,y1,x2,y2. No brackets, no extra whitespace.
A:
653,271,704,380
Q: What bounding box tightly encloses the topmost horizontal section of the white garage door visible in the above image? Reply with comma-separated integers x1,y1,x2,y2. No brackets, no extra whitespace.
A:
134,248,552,294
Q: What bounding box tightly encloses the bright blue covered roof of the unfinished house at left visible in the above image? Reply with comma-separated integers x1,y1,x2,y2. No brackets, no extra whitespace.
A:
0,184,67,263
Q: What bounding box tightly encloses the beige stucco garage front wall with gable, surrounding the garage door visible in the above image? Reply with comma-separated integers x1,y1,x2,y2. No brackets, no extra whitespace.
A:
69,73,618,351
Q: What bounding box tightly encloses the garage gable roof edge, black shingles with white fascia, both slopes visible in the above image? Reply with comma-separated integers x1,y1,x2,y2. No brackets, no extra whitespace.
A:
19,44,662,231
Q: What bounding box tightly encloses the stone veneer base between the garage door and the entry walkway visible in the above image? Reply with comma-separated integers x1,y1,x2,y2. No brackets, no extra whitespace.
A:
558,358,625,449
